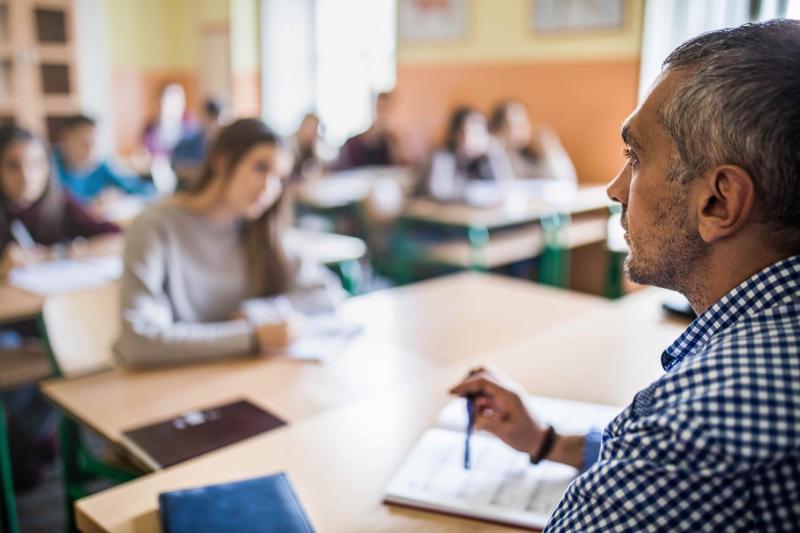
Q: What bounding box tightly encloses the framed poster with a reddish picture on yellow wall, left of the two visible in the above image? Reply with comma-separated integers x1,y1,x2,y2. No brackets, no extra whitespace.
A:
397,0,469,42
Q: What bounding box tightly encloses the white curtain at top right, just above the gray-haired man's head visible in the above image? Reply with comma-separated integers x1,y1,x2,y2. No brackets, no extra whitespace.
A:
639,0,800,101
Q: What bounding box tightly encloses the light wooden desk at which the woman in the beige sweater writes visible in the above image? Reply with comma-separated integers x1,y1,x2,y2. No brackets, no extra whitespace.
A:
42,274,604,450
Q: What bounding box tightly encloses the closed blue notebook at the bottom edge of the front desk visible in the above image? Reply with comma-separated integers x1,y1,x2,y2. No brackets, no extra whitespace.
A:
158,472,314,533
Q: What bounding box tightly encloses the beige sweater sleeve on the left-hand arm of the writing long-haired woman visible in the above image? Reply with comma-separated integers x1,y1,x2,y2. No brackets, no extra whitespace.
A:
115,212,255,366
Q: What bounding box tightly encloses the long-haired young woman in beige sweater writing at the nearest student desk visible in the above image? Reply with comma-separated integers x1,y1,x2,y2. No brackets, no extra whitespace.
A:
116,119,342,365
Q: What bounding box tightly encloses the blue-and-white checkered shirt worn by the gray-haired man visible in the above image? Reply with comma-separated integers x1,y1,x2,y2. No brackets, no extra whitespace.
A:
545,256,800,533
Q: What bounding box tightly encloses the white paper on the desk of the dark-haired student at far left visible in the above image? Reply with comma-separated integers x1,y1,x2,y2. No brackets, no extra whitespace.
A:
8,256,122,295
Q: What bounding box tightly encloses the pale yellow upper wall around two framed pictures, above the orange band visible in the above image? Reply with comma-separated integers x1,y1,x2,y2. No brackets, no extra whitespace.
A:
397,0,644,65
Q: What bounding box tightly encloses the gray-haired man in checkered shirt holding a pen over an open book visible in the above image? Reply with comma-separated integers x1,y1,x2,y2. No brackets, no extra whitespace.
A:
452,20,800,532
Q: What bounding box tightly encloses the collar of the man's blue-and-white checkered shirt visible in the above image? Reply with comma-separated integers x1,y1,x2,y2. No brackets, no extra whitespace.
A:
661,255,800,371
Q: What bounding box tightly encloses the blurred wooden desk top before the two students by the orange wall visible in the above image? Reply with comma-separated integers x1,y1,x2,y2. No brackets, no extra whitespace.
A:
403,185,611,229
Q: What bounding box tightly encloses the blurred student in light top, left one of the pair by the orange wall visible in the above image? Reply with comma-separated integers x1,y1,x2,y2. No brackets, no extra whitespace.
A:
421,107,512,204
